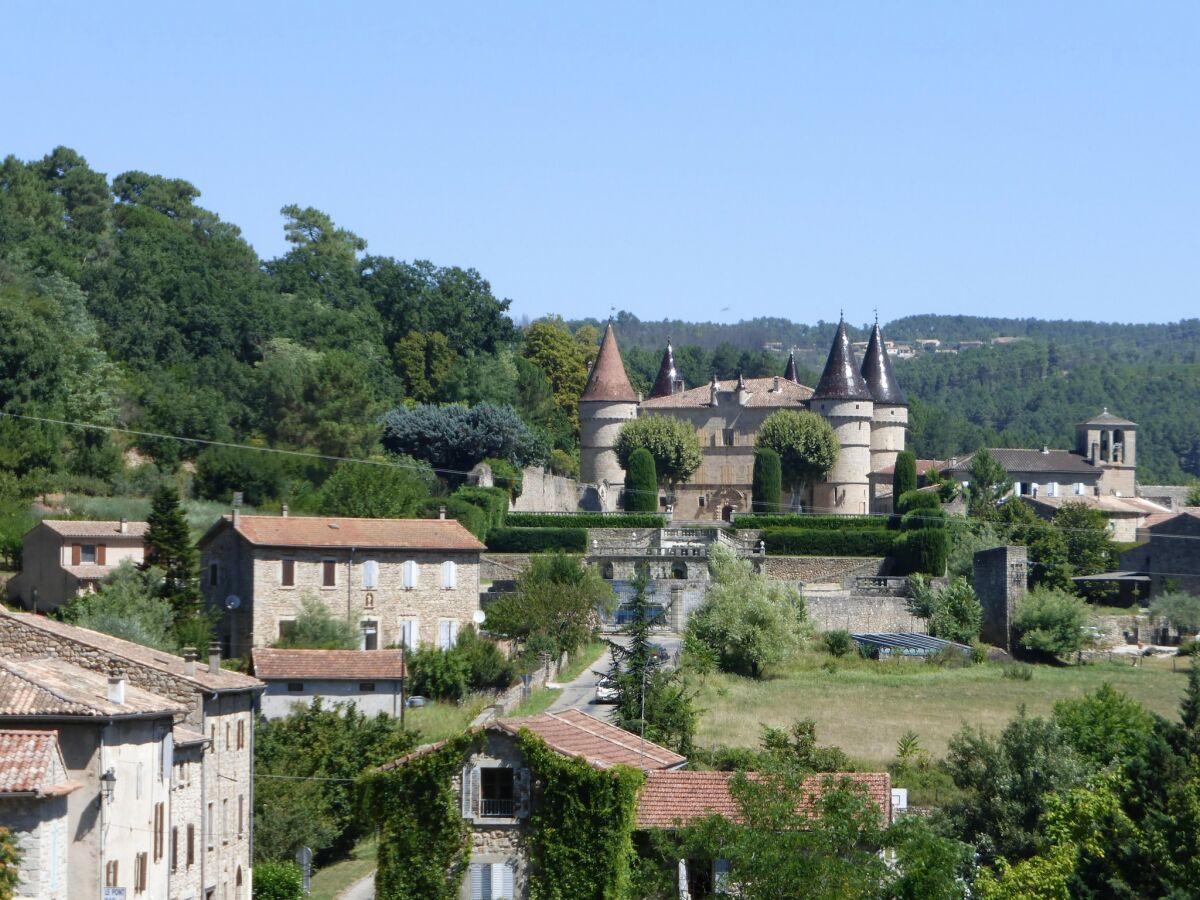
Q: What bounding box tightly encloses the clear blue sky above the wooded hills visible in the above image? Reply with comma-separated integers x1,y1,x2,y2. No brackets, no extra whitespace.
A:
0,0,1200,322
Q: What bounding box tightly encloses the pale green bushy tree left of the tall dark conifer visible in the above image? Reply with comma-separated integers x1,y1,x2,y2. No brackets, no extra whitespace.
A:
61,560,176,653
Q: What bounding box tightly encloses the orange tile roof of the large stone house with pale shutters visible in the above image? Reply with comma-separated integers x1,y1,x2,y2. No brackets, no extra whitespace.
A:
213,516,486,551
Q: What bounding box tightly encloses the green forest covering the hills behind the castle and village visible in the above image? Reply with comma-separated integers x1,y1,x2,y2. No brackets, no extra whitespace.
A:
0,148,1200,518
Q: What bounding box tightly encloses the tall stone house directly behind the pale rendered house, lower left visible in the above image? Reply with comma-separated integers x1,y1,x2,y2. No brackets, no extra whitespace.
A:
0,611,263,900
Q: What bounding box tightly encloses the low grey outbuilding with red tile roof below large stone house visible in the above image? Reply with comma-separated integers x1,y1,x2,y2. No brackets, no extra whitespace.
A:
251,647,404,719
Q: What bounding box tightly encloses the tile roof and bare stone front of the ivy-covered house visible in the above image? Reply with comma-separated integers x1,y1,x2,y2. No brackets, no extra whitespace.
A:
383,709,686,900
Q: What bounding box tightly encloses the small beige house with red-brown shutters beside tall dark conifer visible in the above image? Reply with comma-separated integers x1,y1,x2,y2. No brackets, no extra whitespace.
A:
5,518,148,612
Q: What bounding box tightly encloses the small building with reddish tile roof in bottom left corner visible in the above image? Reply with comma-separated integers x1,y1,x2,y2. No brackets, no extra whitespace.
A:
0,730,83,900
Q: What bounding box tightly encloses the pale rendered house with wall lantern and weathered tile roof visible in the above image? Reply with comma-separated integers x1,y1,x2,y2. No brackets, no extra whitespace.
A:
0,656,185,900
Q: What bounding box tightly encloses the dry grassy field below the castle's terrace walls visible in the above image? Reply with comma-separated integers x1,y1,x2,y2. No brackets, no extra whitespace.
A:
694,652,1188,766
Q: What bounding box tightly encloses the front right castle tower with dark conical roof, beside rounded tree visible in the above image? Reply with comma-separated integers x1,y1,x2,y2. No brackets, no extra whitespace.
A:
810,320,875,515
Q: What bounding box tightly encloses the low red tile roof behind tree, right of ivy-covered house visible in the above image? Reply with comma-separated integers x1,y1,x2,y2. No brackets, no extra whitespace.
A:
637,772,892,828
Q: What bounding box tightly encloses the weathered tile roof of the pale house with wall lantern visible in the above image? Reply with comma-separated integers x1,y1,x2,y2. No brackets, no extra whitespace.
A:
0,656,187,718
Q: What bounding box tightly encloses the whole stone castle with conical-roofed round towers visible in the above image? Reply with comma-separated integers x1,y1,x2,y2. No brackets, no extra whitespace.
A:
580,322,908,521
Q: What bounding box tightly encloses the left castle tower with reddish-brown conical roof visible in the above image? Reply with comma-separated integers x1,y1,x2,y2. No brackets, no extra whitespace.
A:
580,323,638,509
